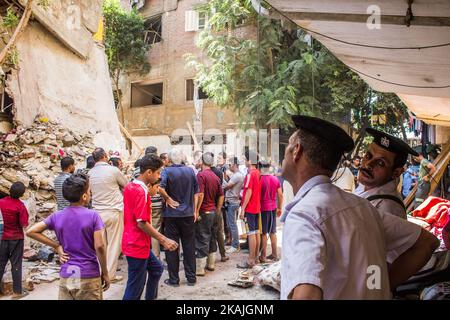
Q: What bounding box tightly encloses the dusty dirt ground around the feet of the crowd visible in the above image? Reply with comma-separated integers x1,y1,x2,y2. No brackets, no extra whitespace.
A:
0,250,279,300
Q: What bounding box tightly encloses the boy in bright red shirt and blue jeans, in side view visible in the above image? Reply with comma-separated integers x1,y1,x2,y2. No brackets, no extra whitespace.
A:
122,154,178,300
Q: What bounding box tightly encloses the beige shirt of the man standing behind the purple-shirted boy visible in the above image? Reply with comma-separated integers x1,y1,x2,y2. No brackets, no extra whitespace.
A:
89,162,128,211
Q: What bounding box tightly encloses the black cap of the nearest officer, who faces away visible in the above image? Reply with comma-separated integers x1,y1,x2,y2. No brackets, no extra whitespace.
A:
292,115,355,153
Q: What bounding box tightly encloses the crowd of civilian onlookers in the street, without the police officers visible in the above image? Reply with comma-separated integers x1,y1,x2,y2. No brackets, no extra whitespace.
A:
0,142,283,300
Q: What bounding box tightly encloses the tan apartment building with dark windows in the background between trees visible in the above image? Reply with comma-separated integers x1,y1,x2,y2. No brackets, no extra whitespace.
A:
119,0,253,158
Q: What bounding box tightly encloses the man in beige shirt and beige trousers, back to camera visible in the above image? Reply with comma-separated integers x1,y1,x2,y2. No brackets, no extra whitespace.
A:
89,148,128,282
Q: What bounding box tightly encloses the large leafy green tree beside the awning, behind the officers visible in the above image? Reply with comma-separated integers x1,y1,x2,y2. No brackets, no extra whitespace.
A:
187,0,412,148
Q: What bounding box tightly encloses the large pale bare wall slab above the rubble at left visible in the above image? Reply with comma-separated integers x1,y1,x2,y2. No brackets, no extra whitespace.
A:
7,22,124,151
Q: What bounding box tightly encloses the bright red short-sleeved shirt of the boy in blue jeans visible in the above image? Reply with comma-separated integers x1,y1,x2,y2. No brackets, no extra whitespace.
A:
122,182,152,259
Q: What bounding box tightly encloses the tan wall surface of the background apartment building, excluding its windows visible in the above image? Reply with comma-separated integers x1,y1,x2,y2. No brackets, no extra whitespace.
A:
121,0,237,144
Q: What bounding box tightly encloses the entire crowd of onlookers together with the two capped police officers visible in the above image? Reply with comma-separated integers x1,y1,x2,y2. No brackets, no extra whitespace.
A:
0,116,438,300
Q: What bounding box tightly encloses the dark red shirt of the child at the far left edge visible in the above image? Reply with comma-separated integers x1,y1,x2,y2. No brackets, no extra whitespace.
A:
0,197,28,240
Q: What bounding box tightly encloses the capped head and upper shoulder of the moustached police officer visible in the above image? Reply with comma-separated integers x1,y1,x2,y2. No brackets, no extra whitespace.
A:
354,128,417,219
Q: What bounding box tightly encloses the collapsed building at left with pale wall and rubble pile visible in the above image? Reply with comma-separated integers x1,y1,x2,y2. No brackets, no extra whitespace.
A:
0,0,125,232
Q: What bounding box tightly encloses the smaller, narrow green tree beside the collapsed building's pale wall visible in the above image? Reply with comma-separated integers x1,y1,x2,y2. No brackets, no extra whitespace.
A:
103,0,150,122
